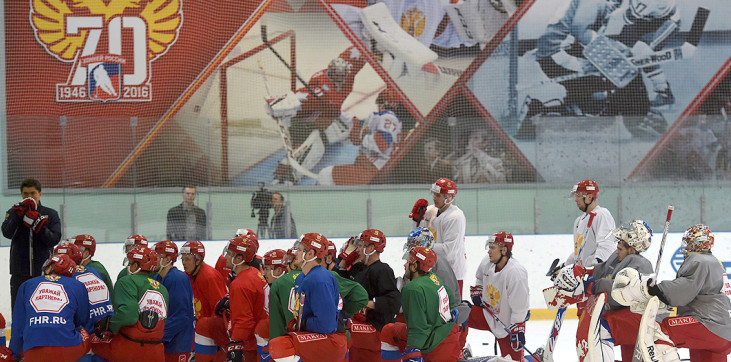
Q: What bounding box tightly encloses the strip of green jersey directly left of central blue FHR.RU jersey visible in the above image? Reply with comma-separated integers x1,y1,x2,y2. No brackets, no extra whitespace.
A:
269,270,302,341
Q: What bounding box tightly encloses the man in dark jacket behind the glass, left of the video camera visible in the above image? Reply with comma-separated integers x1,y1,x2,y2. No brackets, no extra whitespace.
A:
167,186,207,241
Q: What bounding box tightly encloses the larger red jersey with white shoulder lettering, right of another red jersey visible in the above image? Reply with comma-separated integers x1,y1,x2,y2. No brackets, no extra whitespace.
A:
229,267,269,350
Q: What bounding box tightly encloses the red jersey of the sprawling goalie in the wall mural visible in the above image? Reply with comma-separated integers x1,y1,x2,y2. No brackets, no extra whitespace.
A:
296,46,365,127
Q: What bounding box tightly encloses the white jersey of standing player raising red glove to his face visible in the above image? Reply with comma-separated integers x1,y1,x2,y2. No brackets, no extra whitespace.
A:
431,204,467,280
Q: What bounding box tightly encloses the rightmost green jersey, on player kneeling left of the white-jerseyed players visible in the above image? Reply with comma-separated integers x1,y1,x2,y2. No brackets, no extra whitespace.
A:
401,273,457,353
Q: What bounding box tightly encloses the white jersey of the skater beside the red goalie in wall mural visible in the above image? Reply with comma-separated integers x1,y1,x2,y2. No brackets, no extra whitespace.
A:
359,111,401,170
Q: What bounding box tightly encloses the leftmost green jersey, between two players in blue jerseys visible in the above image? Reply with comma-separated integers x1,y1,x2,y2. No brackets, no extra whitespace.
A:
109,272,169,333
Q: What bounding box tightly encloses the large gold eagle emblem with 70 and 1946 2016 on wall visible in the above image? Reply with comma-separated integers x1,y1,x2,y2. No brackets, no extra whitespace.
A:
30,0,183,102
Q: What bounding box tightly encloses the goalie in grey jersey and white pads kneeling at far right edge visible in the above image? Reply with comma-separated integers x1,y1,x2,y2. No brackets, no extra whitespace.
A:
612,224,731,362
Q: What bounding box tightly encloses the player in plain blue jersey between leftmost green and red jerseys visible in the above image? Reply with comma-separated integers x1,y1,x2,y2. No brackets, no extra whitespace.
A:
154,240,195,362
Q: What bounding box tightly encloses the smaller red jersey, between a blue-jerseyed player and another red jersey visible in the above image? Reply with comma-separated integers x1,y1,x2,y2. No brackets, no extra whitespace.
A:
188,262,227,320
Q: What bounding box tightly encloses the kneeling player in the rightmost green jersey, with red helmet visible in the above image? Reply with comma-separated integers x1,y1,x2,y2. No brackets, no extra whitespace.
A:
381,246,460,362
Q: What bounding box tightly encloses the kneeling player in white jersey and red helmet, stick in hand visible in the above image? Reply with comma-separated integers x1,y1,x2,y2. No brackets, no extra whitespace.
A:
468,231,530,361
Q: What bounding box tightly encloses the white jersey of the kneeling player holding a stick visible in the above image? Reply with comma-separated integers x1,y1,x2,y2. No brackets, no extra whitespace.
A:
475,256,530,338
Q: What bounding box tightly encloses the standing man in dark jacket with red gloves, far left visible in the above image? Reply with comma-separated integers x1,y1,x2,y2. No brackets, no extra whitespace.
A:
2,178,61,308
